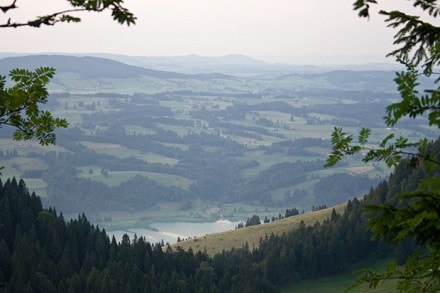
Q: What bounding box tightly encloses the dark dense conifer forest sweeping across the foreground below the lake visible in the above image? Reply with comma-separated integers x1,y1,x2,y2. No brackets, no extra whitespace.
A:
0,141,440,292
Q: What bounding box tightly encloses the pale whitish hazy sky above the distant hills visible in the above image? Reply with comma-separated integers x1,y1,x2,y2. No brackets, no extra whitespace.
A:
0,0,420,64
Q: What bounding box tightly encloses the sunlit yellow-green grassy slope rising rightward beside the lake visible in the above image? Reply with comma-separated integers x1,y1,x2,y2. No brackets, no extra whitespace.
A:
171,203,346,256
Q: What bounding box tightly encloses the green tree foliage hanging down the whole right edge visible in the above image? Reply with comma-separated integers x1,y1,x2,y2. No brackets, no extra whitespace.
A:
326,0,440,292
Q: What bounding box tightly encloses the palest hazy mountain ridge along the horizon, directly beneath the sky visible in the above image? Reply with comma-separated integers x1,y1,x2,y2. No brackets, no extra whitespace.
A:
0,52,400,78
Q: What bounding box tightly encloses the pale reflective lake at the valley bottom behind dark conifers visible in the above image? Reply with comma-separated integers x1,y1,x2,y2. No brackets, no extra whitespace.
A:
107,219,239,243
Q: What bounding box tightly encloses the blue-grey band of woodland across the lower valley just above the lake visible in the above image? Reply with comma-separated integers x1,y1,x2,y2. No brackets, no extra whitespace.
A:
15,139,377,213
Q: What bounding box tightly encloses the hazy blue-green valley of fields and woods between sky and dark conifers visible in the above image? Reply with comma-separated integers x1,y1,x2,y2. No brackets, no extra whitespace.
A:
0,54,434,238
